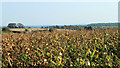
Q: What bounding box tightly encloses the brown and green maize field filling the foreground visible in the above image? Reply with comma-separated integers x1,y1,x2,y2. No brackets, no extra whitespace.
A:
2,28,120,68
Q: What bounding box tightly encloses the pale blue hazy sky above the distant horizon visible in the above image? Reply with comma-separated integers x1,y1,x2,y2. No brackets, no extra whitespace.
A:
2,0,118,26
